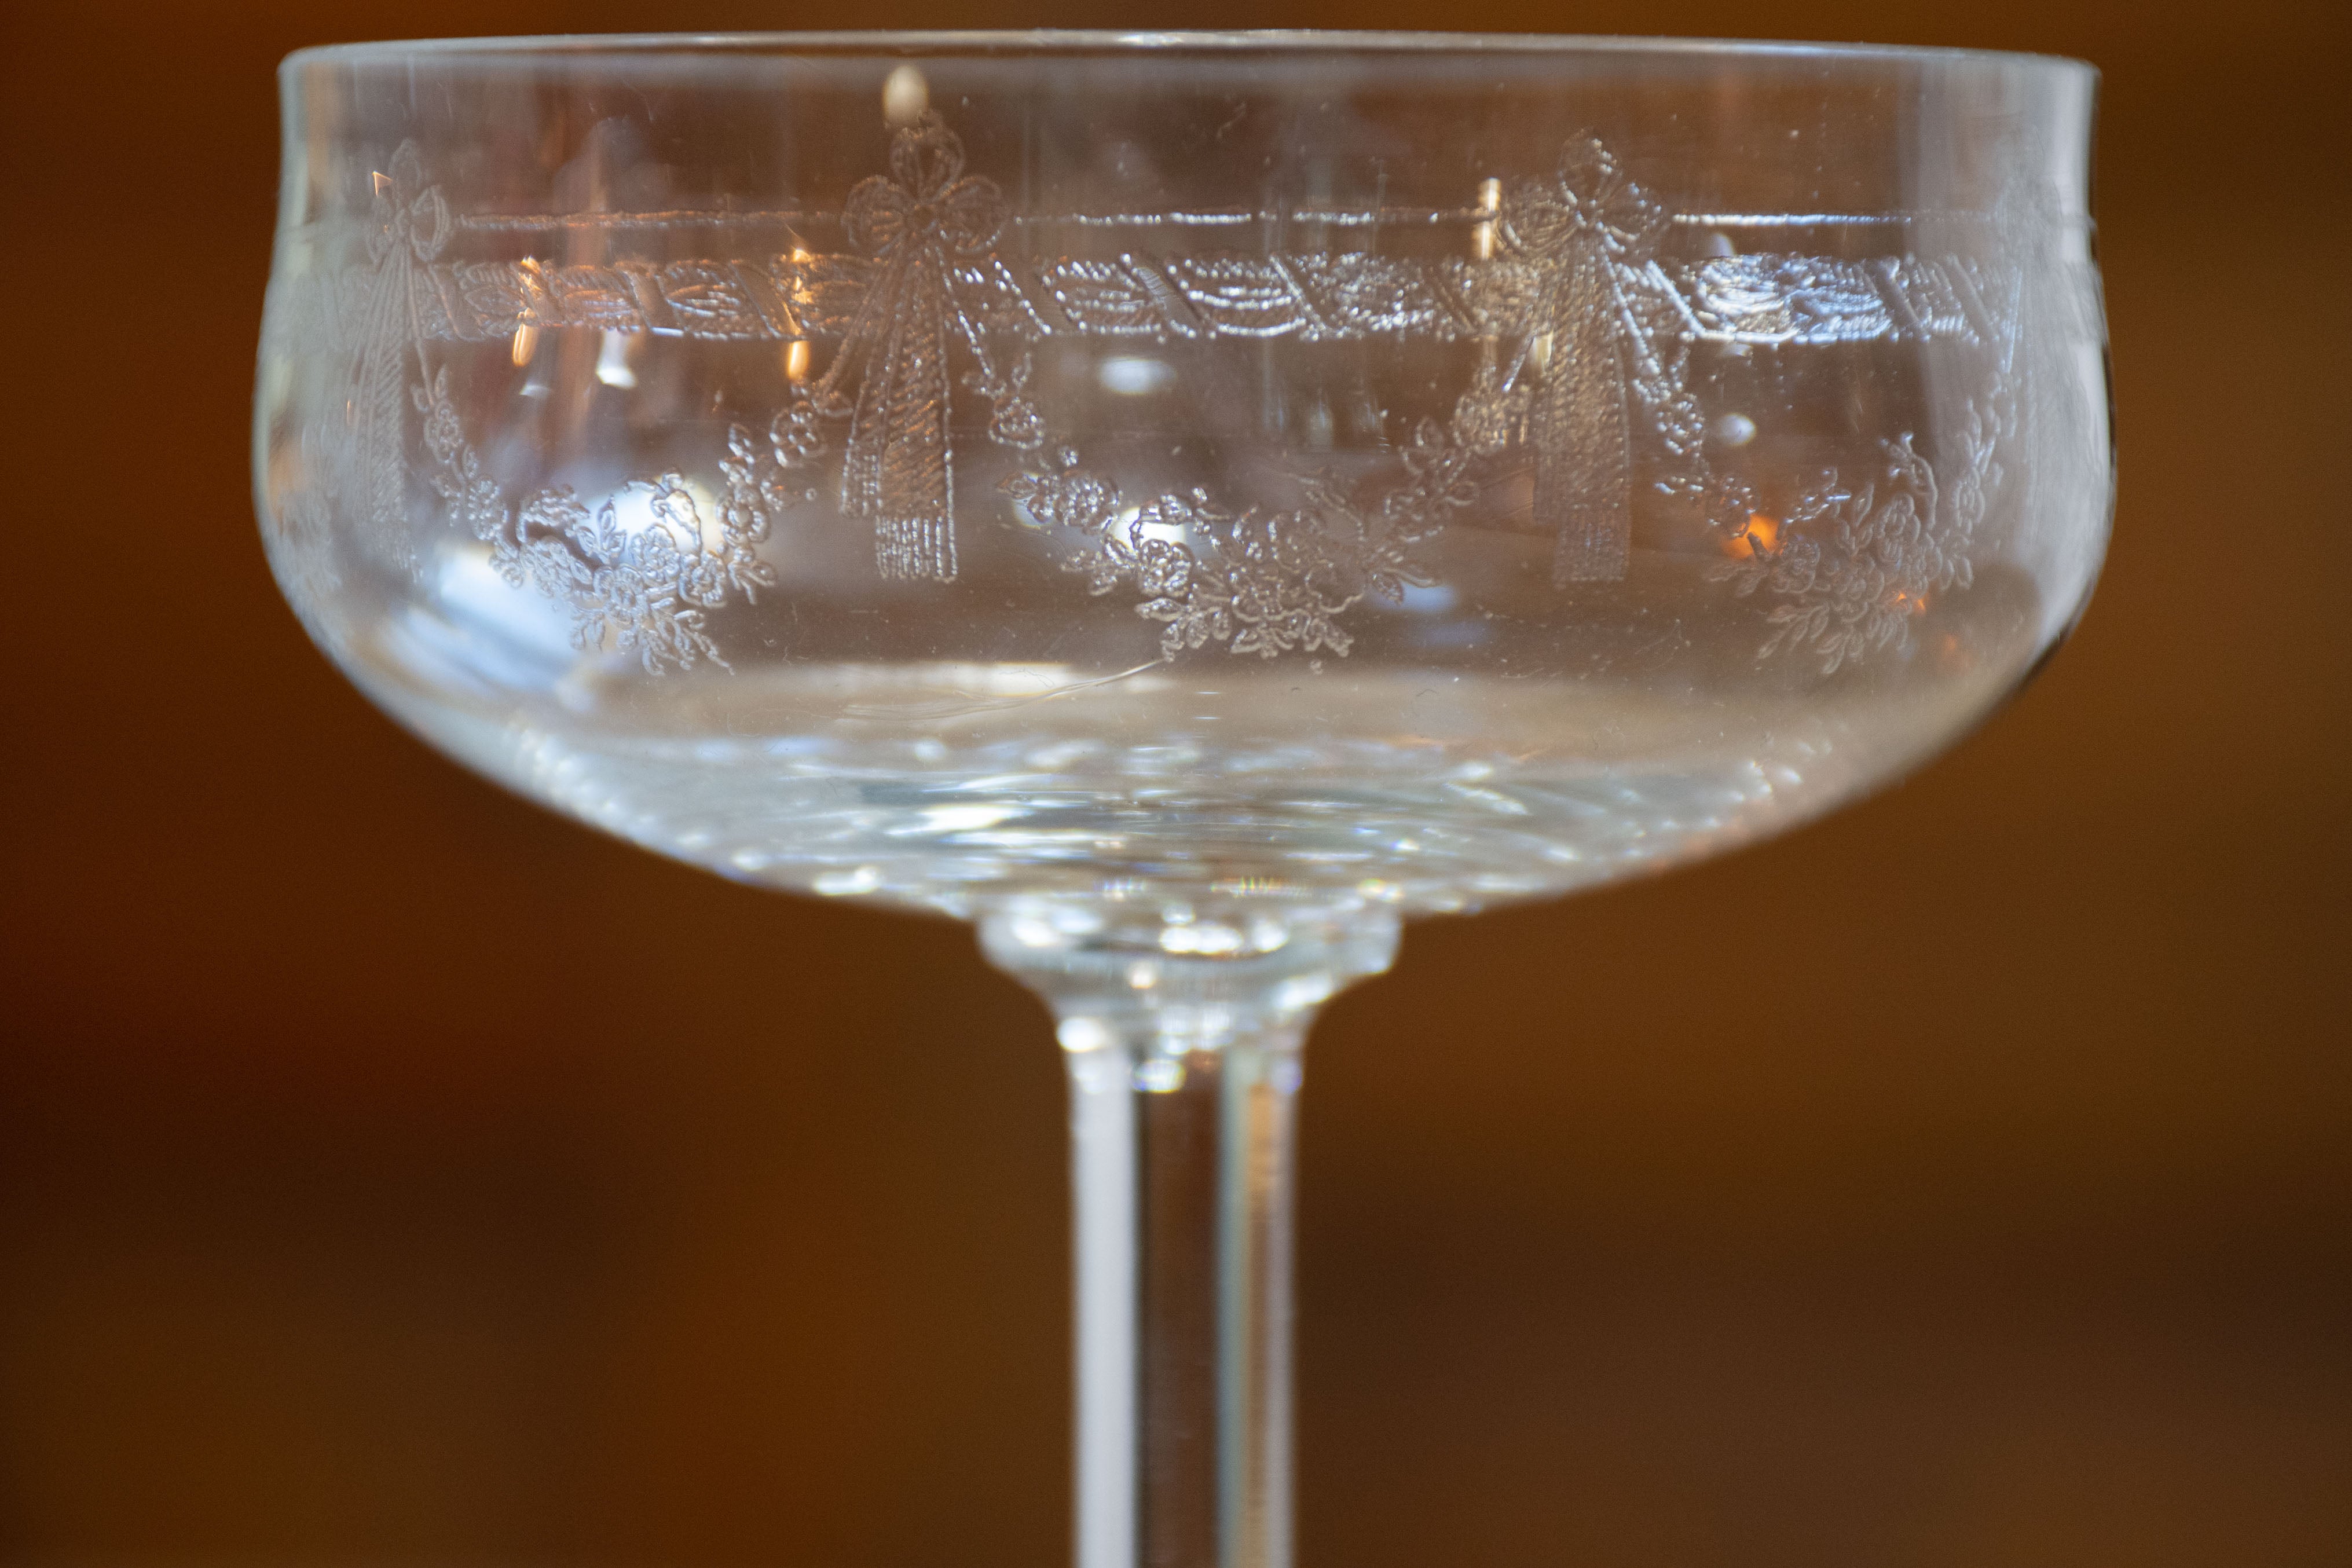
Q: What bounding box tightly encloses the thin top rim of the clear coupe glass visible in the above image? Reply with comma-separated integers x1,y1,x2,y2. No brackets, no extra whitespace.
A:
280,28,2098,78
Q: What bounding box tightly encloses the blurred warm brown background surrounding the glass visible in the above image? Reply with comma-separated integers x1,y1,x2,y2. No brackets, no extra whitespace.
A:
0,0,2352,1568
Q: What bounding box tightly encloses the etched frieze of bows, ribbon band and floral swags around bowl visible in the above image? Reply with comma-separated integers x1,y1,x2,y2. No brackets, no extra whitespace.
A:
287,113,2060,672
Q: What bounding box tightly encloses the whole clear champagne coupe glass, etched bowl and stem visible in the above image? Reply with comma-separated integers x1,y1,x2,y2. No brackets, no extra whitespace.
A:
254,33,2112,1568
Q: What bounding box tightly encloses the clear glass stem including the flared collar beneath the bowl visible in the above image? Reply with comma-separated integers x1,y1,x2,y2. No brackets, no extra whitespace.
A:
983,905,1397,1568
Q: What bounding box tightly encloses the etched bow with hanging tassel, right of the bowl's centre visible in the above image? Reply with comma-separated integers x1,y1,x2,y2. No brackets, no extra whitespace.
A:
1496,136,1665,585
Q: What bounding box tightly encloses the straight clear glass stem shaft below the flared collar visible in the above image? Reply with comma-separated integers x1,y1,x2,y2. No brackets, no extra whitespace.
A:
1068,1030,1300,1568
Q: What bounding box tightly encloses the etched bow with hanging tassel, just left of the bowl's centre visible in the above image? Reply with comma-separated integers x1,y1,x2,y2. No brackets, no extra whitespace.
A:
811,113,1007,581
